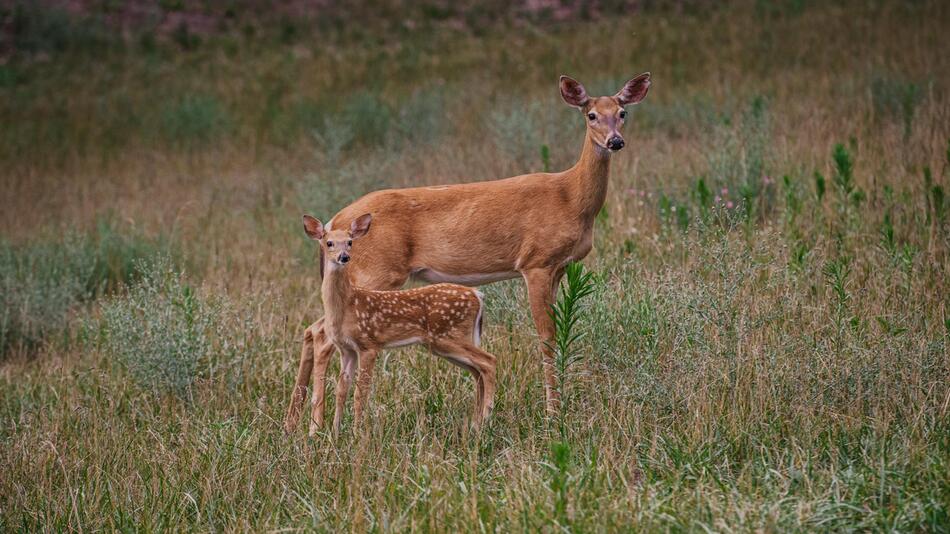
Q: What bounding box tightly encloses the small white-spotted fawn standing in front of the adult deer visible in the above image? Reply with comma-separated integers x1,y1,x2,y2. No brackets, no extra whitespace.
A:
297,214,495,436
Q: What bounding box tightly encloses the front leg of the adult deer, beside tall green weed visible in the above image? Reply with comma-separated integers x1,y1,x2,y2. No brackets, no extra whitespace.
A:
522,269,560,414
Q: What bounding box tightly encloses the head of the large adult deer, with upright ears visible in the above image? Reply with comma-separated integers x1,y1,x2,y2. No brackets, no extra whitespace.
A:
561,72,650,152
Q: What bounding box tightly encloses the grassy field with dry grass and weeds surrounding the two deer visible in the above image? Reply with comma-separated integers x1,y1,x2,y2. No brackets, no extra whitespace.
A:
0,1,950,532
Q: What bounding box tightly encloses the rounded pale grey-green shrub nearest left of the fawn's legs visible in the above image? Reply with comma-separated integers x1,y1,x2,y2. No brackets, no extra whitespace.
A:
98,259,251,396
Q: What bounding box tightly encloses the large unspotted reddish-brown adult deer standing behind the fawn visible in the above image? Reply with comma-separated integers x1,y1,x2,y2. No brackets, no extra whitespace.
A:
284,72,650,431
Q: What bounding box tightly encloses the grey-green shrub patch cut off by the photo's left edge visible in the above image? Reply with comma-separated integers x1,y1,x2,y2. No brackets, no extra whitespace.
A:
0,221,167,354
